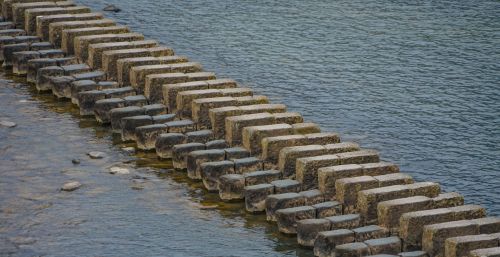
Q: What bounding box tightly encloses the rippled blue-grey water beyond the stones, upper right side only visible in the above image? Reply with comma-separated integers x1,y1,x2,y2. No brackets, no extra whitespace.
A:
78,0,500,210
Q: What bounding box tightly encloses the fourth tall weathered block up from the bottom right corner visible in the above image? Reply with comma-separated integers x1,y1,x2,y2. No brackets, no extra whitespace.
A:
399,205,486,251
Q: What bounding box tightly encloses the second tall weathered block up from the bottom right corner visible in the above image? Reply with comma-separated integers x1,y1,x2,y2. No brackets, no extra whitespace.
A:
444,234,499,257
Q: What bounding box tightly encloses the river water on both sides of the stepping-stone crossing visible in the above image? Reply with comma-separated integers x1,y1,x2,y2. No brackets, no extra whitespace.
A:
0,0,500,256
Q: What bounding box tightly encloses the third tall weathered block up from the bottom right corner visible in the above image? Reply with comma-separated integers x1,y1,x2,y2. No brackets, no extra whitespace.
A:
422,220,479,256
